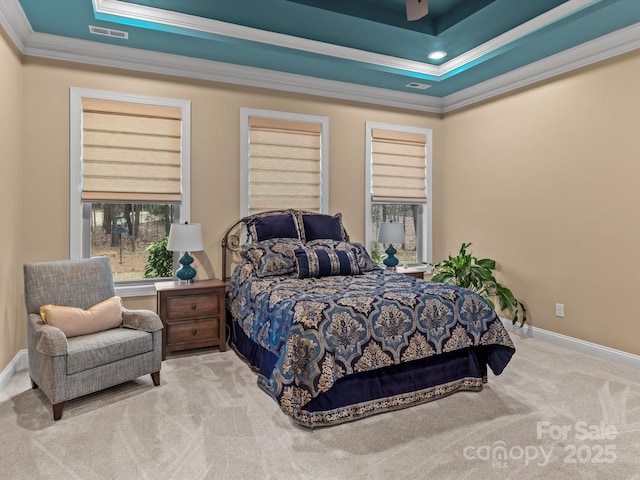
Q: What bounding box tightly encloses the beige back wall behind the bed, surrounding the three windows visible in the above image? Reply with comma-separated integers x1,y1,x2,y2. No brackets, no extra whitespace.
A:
0,58,442,369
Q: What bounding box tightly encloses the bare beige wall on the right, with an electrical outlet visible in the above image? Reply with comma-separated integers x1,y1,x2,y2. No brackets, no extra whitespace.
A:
434,51,640,354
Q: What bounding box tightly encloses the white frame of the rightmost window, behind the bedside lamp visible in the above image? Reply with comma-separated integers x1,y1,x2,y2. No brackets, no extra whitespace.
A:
364,122,433,267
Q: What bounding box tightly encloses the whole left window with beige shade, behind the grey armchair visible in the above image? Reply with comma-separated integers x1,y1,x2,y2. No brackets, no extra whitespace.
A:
69,88,190,296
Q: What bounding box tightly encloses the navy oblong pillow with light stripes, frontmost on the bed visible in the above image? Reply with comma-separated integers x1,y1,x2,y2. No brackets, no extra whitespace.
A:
295,248,361,278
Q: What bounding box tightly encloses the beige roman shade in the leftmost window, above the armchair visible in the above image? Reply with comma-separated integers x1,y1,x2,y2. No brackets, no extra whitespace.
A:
82,98,182,203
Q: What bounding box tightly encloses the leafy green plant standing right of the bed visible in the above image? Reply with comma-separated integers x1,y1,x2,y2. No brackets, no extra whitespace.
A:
431,243,527,327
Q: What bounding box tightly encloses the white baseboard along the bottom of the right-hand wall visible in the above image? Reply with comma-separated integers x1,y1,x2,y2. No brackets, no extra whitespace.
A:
500,318,640,370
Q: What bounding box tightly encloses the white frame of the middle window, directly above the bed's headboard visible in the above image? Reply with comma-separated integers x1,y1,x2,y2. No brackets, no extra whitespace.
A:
240,107,329,217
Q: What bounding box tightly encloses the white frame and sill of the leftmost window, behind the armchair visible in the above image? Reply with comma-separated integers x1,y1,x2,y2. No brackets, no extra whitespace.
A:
69,87,191,297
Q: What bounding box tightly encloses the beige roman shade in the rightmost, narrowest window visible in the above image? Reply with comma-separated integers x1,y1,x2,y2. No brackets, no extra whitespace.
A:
371,128,427,203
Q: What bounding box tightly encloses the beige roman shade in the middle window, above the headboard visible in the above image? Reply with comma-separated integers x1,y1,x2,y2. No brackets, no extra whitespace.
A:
249,116,322,214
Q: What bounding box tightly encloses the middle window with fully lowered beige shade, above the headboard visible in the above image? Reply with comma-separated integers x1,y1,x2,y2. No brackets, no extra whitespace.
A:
240,108,329,216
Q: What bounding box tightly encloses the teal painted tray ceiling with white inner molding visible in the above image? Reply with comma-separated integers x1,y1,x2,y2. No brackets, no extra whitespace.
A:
8,0,640,104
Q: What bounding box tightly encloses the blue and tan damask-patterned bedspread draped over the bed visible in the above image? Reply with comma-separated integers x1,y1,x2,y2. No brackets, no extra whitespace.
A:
228,261,515,424
